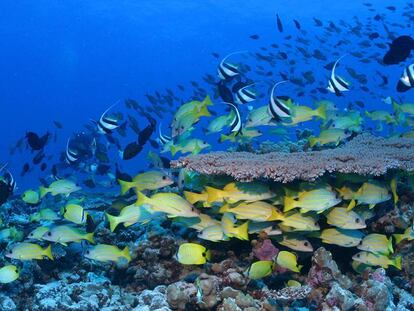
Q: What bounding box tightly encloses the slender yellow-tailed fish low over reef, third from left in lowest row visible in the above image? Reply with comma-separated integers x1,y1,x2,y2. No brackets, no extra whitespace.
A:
85,244,131,262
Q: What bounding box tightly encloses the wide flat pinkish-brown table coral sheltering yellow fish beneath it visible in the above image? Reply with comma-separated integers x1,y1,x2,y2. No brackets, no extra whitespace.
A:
171,134,414,183
